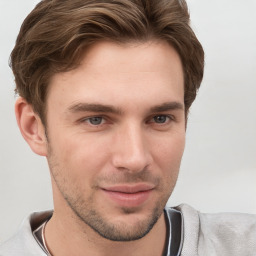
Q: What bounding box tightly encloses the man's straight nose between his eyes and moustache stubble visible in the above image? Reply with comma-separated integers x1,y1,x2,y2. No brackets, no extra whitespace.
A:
112,122,151,172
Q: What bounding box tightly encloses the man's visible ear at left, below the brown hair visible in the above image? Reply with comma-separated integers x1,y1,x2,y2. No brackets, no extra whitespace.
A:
15,97,47,156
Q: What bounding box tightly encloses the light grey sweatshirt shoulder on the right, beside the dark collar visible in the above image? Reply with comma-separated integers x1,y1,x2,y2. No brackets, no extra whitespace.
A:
173,205,256,256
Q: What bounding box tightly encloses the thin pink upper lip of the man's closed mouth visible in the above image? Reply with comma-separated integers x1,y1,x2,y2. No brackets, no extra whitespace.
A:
102,183,155,194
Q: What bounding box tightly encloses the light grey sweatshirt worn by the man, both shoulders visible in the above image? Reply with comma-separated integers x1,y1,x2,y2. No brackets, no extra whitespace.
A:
0,205,256,256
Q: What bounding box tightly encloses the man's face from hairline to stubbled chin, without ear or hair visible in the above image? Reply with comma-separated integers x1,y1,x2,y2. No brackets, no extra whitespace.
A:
47,42,185,241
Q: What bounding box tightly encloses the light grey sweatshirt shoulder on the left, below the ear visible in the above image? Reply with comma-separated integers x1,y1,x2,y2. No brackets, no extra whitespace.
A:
0,211,52,256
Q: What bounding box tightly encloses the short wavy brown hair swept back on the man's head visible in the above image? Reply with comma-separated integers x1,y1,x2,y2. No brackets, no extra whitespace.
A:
10,0,204,123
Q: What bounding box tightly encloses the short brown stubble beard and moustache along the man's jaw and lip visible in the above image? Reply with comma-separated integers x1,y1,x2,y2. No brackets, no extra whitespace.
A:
48,144,174,241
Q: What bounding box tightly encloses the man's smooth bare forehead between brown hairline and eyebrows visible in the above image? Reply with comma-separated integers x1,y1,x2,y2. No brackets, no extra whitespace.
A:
48,41,184,111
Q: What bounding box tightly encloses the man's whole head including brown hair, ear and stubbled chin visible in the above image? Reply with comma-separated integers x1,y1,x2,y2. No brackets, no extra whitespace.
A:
11,0,204,243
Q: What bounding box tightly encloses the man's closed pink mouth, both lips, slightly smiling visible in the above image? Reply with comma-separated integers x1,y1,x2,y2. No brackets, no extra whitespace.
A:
102,184,154,207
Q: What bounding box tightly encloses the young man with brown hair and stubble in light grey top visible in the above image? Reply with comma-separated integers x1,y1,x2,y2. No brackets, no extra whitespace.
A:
0,0,256,256
